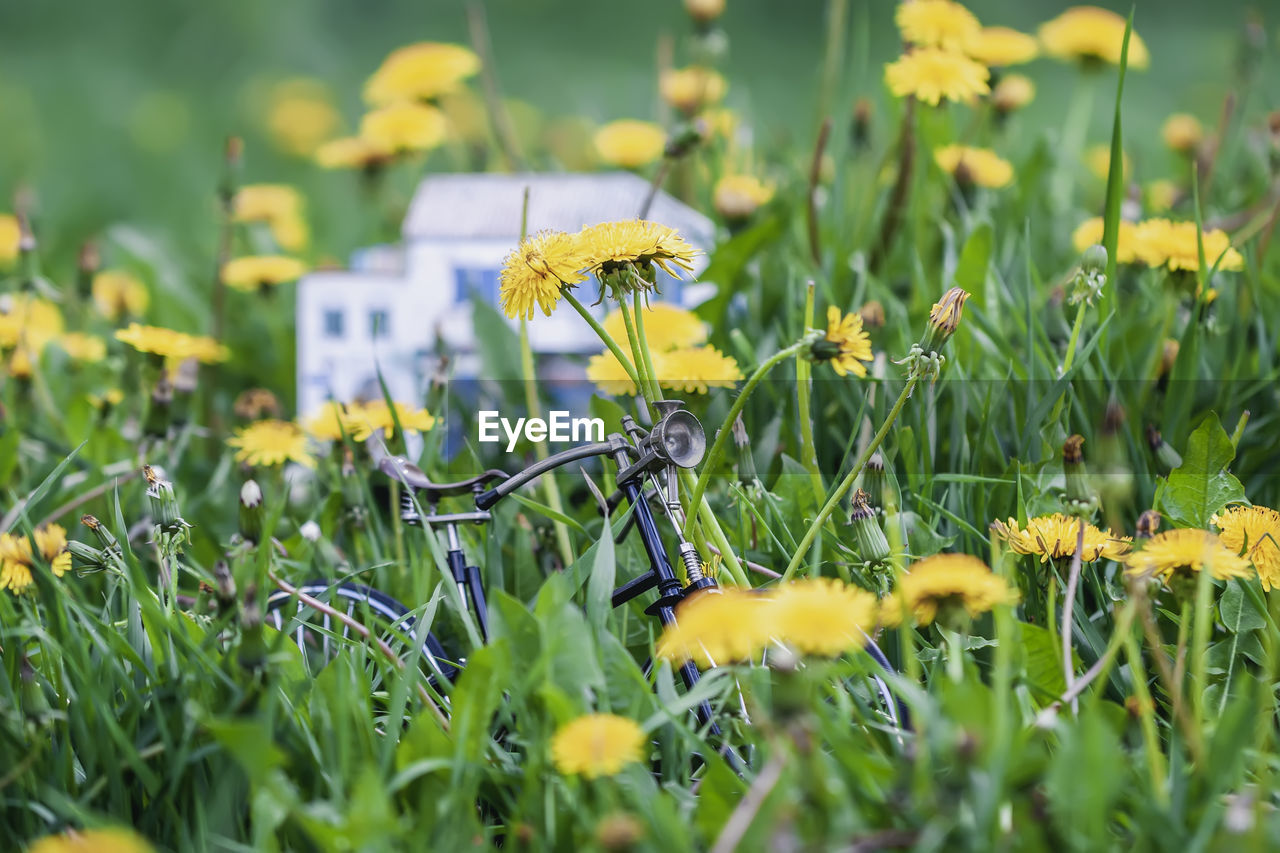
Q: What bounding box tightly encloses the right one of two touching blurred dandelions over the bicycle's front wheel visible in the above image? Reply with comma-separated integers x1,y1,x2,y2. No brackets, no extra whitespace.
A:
765,578,877,657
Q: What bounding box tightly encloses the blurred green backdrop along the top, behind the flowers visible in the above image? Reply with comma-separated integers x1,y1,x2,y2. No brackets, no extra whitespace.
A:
0,0,1280,285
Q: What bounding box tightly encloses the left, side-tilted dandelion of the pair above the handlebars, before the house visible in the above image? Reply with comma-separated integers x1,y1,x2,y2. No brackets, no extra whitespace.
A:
498,231,589,320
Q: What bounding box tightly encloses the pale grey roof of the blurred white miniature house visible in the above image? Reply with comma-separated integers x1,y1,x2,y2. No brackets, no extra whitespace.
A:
403,172,716,242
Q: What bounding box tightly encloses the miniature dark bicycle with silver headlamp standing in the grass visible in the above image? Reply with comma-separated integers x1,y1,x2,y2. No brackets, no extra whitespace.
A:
266,400,910,734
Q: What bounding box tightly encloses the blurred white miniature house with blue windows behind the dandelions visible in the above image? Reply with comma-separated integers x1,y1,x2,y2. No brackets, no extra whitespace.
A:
297,172,714,414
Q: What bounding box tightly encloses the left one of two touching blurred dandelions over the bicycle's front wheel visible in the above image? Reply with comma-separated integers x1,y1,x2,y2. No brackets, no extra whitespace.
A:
655,587,771,667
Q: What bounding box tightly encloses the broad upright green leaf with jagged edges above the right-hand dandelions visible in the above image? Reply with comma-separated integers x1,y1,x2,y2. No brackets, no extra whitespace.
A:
1161,412,1244,528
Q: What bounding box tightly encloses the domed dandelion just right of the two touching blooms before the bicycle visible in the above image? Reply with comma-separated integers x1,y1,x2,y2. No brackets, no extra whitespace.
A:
881,553,1018,625
